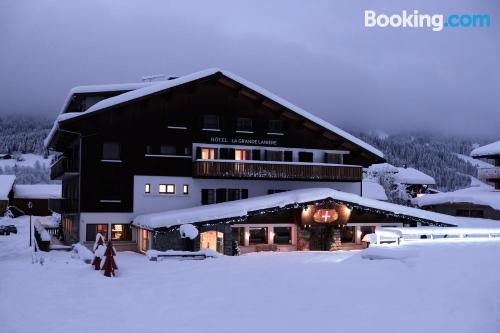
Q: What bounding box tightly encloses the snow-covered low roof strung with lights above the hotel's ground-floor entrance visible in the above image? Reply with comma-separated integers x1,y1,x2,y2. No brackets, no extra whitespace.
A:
132,188,500,230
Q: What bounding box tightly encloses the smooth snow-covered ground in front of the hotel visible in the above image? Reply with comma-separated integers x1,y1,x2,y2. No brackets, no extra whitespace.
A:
0,217,500,333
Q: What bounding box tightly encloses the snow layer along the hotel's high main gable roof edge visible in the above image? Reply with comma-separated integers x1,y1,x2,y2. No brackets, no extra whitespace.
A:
45,68,384,158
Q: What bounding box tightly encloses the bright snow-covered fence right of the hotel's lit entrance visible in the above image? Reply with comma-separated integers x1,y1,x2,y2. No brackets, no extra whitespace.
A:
375,227,500,244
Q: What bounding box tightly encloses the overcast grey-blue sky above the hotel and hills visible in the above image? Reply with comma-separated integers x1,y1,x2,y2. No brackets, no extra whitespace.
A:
0,0,500,137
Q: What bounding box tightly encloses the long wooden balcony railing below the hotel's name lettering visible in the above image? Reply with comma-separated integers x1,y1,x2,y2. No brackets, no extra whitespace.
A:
193,160,362,181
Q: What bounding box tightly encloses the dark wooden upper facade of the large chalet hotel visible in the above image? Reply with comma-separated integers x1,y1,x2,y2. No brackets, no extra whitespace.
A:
49,73,383,248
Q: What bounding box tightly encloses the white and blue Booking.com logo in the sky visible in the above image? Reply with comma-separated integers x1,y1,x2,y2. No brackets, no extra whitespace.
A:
365,10,491,31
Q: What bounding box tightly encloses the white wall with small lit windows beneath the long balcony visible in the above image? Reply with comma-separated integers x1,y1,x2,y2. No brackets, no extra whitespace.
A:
134,176,361,216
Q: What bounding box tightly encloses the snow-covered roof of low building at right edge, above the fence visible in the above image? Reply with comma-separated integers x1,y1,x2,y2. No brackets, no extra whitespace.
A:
414,186,500,211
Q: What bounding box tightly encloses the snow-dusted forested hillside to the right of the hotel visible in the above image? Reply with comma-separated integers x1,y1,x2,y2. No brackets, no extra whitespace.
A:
358,133,493,191
